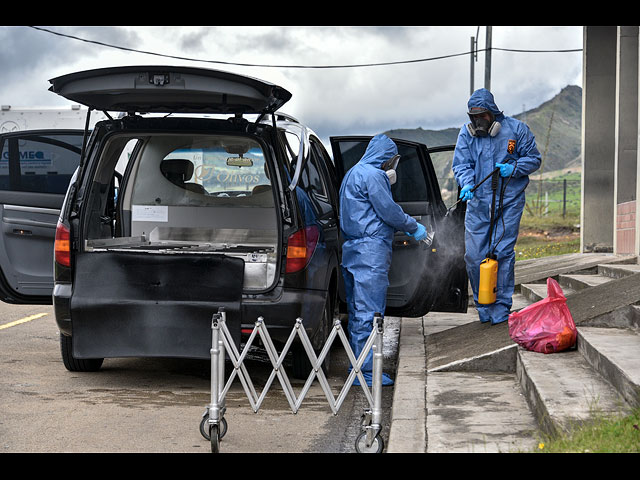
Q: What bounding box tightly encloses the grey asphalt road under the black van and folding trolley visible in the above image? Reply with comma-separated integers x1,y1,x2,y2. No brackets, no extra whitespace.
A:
0,303,399,453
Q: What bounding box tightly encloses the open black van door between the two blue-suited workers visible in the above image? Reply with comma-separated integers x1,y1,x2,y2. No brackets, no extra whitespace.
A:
330,136,468,317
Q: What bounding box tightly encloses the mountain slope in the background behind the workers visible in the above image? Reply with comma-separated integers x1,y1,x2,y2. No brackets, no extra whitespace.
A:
385,85,582,177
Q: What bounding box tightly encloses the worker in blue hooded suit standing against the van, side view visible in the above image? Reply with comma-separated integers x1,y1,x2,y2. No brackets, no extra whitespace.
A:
340,135,427,386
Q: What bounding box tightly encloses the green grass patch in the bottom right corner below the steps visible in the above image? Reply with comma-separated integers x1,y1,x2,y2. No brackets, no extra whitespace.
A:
535,408,640,453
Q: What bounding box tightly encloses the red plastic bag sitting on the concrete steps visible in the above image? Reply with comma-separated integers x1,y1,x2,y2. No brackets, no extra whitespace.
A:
509,278,578,353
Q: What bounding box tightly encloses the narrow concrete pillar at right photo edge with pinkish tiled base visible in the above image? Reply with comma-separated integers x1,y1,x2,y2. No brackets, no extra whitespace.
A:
613,26,638,254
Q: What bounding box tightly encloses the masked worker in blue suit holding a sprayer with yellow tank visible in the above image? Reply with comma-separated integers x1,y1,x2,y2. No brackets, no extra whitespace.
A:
452,88,540,325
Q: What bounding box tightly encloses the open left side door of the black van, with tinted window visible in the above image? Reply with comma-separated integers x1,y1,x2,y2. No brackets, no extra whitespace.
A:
0,130,84,304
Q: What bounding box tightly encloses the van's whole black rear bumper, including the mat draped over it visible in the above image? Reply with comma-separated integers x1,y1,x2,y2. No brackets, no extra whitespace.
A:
53,254,327,359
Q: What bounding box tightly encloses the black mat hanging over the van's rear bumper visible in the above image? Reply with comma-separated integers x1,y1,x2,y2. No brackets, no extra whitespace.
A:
54,252,244,359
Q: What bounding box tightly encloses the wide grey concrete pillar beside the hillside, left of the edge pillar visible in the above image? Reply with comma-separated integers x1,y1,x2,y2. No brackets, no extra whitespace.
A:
580,26,617,252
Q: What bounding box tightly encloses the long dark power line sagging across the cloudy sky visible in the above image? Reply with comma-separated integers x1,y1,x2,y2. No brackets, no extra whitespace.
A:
29,26,582,69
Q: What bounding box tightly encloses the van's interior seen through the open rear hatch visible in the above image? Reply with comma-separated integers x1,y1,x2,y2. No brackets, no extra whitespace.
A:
84,133,278,291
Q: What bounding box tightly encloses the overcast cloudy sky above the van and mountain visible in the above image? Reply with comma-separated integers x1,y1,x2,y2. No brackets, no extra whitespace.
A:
0,26,583,140
